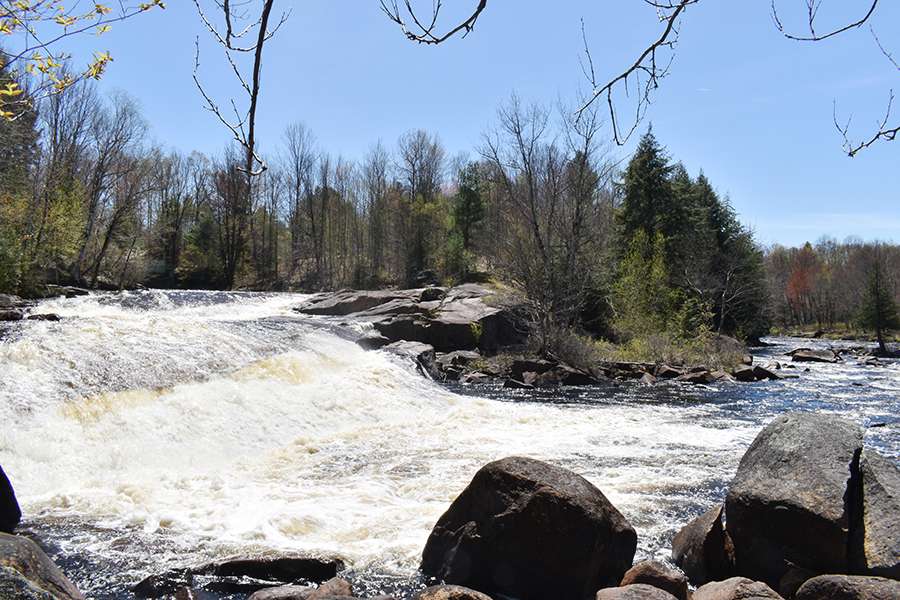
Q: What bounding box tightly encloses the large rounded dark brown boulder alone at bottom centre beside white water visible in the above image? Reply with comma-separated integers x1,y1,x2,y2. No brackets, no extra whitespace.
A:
422,457,637,600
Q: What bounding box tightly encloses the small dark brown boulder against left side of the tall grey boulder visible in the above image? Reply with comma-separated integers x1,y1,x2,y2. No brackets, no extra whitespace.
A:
672,505,734,585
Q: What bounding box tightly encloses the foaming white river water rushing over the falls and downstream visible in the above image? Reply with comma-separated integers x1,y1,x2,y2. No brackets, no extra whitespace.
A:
0,291,900,599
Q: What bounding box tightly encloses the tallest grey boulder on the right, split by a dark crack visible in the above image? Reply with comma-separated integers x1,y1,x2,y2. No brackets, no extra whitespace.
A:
725,413,863,587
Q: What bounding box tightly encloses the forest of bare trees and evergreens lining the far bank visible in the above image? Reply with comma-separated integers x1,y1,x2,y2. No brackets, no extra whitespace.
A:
0,69,900,348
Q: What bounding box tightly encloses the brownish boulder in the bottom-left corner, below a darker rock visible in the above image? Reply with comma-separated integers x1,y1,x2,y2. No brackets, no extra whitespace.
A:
0,533,84,600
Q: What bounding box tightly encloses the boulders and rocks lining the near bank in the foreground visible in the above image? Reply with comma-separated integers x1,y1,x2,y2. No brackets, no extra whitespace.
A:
0,413,900,600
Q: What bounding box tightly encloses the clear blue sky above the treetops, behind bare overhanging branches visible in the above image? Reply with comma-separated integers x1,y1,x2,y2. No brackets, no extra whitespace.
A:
61,0,900,244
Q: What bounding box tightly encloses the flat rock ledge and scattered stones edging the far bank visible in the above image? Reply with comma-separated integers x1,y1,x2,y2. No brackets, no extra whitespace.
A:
296,284,892,389
